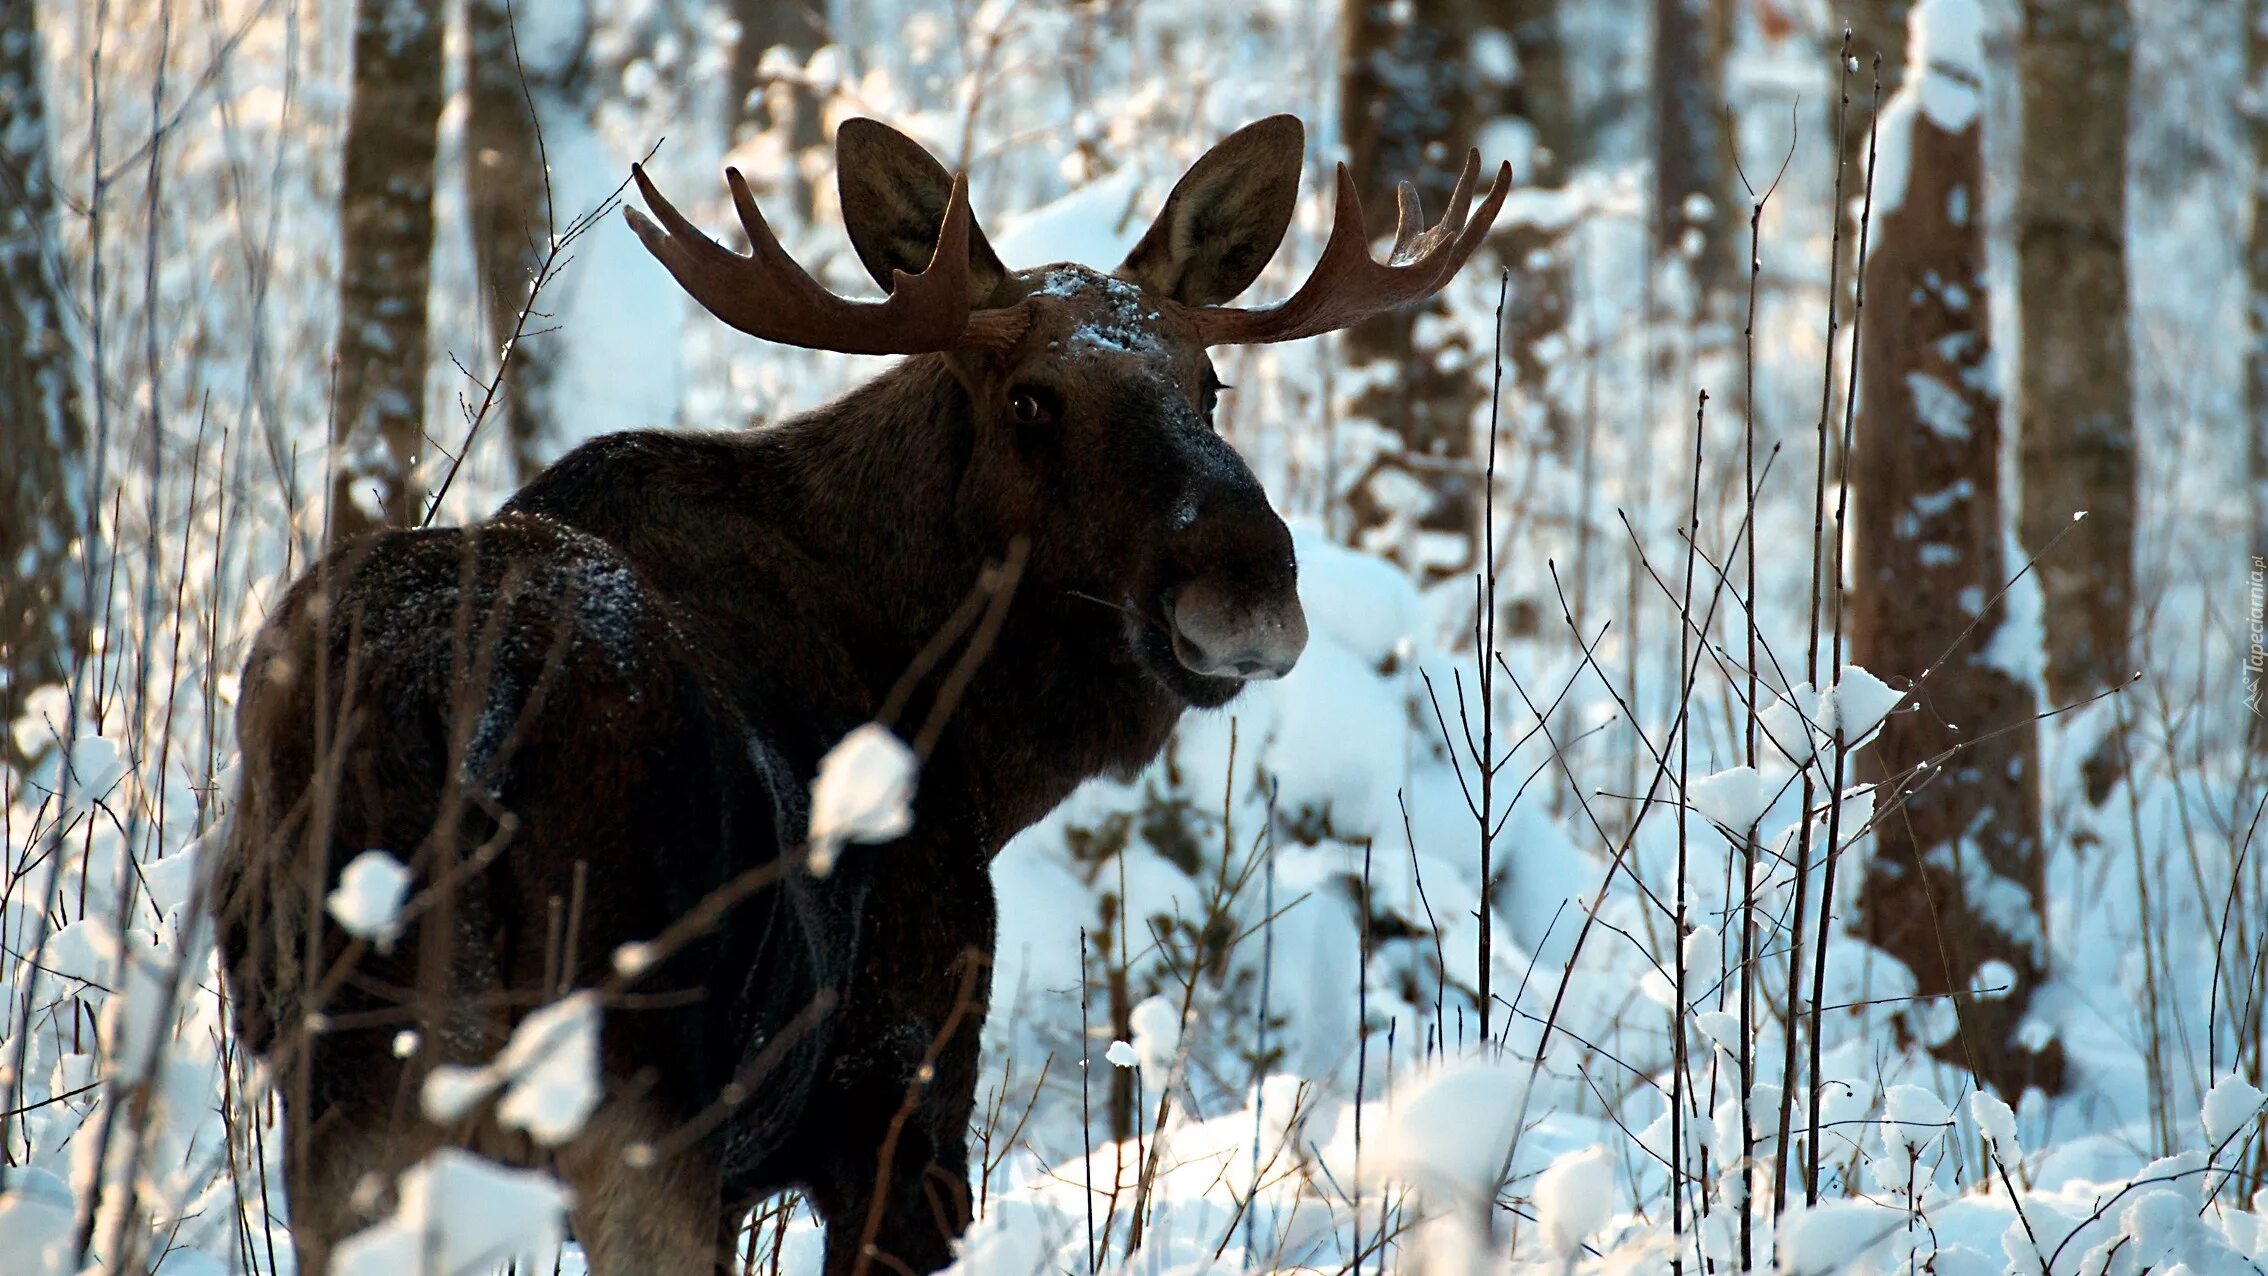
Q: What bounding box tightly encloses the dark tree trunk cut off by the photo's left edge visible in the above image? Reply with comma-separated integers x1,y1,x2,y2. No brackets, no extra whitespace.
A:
0,2,86,756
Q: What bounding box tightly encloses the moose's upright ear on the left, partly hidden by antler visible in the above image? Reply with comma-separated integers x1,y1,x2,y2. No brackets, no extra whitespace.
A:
835,118,1007,306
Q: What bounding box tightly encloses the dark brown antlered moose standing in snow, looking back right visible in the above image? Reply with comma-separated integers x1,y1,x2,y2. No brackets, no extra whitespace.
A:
215,116,1510,1276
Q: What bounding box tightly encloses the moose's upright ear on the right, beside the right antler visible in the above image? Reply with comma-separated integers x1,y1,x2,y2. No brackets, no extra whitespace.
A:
1118,116,1306,306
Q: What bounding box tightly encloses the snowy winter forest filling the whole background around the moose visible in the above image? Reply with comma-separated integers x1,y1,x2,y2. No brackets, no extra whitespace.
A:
0,0,2268,1276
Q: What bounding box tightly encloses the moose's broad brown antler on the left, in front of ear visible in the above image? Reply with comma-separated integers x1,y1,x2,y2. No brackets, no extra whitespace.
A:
621,163,1025,354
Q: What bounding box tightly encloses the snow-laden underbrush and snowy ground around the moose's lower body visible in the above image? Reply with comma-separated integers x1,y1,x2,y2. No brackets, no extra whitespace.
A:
0,523,2268,1276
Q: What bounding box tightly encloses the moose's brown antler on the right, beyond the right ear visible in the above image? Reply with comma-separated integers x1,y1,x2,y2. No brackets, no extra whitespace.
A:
1184,150,1513,344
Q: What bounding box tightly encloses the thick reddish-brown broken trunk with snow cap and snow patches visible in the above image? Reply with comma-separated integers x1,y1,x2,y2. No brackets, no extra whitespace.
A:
1851,17,2064,1097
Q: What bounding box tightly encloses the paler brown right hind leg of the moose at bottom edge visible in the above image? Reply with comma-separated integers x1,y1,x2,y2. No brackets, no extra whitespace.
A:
558,1099,733,1276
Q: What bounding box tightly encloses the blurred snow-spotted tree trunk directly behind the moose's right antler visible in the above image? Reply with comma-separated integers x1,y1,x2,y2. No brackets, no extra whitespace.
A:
1340,0,1574,580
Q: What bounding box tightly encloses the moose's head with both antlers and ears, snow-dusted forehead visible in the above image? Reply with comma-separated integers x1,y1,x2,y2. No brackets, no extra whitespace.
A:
626,116,1510,707
